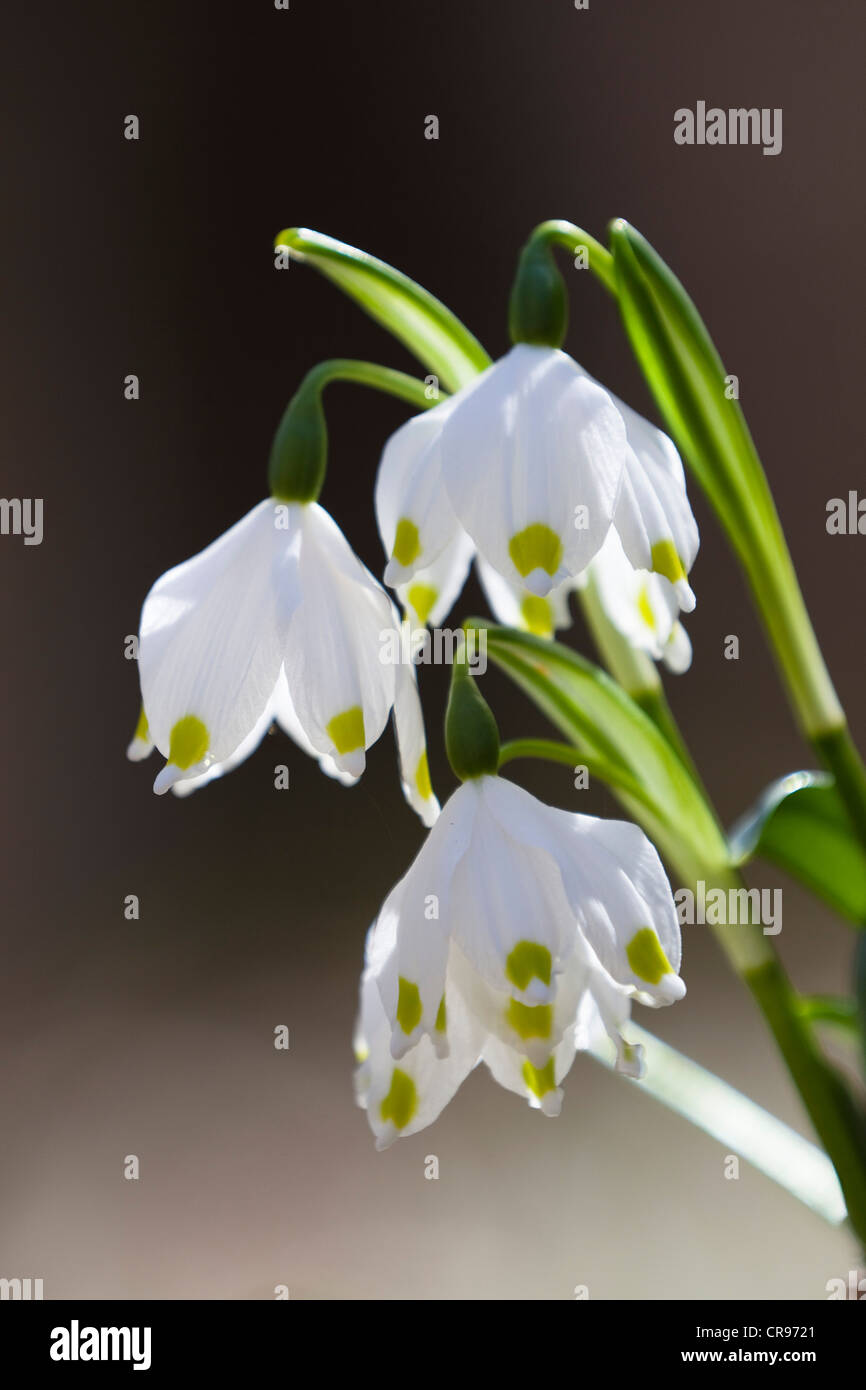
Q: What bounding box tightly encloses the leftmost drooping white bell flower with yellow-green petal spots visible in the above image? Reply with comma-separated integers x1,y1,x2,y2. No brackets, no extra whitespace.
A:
129,499,438,824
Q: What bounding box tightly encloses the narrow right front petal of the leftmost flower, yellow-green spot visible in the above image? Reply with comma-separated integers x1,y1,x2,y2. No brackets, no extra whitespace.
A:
285,503,399,777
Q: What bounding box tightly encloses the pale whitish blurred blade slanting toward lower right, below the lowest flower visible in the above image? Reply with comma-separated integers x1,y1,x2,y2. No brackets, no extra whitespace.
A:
591,1023,845,1226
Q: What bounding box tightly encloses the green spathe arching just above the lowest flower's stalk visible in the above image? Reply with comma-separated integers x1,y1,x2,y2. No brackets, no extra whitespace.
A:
475,619,728,880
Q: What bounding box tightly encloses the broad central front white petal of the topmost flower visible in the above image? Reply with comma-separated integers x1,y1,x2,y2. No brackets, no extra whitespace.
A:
441,345,627,598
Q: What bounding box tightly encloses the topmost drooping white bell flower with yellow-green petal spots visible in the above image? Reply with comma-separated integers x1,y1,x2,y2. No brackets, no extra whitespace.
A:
375,343,698,631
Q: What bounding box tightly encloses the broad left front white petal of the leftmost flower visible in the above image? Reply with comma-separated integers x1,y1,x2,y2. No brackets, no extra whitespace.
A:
139,499,299,790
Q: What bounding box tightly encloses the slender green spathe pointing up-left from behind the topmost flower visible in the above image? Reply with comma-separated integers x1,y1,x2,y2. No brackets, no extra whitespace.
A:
274,227,491,391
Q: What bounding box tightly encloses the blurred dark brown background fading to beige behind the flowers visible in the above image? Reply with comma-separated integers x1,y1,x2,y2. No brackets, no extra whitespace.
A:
0,0,866,1298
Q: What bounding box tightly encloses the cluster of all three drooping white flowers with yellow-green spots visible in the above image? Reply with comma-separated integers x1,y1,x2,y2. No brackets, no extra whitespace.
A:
129,296,698,1147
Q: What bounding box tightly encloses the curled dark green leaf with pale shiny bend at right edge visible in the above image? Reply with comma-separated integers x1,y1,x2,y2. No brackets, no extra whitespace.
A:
730,771,866,926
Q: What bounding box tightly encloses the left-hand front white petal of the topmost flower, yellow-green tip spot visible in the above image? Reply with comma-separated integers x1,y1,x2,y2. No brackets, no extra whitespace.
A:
375,399,460,587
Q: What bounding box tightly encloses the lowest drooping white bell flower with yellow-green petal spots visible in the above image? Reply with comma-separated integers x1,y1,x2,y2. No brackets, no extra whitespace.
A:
356,776,685,1148
